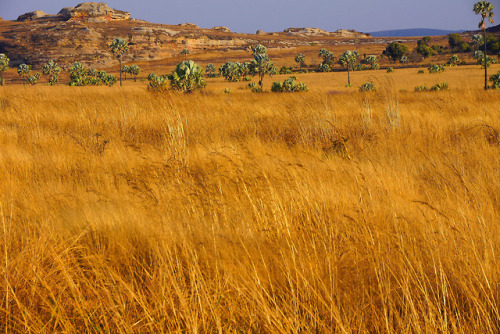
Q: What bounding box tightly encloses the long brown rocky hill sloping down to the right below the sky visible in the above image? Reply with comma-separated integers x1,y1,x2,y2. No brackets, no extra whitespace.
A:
0,2,376,66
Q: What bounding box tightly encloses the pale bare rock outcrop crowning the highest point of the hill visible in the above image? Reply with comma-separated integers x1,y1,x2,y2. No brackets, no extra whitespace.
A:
57,2,130,22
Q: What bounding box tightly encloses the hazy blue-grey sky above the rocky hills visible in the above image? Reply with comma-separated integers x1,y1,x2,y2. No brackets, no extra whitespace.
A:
0,0,500,33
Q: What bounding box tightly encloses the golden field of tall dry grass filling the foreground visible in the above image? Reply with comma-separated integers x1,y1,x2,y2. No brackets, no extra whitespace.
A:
0,65,500,333
